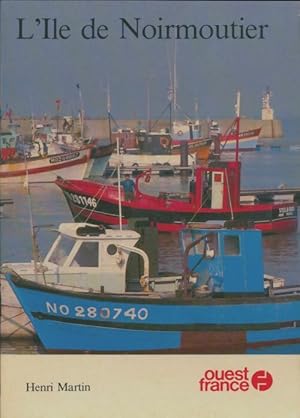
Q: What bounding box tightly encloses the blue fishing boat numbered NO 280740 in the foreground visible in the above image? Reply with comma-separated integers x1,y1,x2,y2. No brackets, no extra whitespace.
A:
6,224,300,354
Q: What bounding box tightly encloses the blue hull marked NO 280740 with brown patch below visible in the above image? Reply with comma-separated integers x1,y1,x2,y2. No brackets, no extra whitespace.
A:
7,274,300,353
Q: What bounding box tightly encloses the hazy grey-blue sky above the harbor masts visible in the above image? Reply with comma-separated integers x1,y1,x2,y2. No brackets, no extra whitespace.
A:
0,0,300,120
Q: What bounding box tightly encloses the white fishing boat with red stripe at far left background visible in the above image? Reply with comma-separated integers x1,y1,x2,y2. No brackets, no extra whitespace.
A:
0,123,113,184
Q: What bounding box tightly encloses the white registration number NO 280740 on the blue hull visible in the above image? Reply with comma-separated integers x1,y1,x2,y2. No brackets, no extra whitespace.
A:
46,302,148,321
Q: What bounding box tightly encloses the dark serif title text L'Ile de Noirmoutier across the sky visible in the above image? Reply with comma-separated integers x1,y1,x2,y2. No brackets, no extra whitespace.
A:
17,17,269,40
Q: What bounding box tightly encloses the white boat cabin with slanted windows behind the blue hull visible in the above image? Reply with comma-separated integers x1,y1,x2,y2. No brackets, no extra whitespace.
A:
43,223,145,293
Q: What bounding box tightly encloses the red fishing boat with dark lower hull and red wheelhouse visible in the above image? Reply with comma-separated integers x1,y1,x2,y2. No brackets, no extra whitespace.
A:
55,154,297,233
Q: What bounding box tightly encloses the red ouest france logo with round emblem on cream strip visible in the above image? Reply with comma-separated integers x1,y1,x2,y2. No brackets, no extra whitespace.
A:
198,367,273,392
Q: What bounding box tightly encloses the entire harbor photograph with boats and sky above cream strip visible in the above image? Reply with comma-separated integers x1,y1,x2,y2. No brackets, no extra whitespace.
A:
0,1,300,355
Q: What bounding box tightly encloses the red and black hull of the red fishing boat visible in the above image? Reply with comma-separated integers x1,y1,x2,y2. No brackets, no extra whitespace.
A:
56,180,297,233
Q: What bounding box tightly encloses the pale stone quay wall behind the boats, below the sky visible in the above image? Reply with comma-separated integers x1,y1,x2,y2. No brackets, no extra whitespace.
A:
1,118,283,139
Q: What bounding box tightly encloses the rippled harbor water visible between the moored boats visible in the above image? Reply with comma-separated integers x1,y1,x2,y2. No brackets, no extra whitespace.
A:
1,122,300,354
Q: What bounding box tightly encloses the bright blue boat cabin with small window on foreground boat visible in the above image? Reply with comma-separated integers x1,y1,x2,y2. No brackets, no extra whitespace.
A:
180,224,264,296
